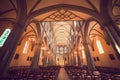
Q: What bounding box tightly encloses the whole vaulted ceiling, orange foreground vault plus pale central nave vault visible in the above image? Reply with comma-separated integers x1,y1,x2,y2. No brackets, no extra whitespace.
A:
0,0,120,53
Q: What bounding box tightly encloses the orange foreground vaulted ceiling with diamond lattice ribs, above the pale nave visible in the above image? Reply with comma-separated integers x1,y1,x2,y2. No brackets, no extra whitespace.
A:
0,0,120,21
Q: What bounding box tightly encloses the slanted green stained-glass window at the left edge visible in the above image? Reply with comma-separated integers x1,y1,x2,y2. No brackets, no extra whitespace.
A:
0,28,11,47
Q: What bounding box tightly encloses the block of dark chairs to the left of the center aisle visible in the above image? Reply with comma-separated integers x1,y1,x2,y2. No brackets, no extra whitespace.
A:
0,66,60,80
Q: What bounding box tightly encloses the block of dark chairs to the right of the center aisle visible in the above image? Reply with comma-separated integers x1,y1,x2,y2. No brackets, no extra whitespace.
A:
64,66,120,80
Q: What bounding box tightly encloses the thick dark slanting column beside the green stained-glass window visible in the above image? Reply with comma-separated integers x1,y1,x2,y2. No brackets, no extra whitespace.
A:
0,23,24,76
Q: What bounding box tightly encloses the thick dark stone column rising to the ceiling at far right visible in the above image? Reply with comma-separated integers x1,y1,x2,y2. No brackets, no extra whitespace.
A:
100,0,120,54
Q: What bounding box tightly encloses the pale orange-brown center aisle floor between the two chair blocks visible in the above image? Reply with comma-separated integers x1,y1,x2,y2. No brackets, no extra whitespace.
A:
57,67,70,80
